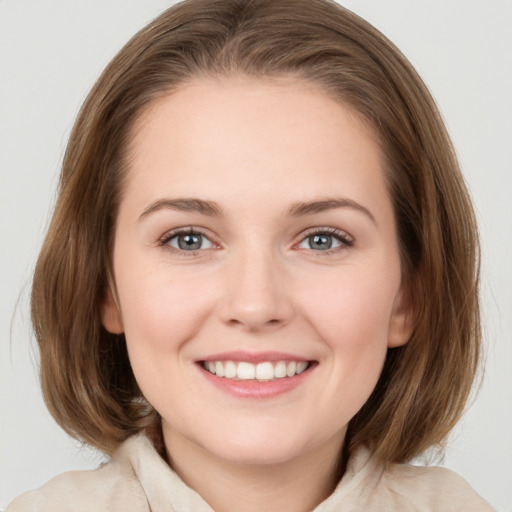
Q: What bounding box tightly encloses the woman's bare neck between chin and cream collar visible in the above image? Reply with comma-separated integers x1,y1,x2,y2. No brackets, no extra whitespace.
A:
164,431,342,512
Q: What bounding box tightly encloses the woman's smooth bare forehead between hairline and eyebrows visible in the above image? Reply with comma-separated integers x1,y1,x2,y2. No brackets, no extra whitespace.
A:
122,77,390,216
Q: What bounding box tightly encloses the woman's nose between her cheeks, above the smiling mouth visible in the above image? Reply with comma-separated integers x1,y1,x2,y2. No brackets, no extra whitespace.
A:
219,247,294,332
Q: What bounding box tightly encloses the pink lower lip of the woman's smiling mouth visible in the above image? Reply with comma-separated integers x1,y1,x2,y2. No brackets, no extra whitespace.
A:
198,364,315,398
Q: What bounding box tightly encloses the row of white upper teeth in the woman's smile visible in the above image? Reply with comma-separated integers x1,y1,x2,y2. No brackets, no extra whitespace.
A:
203,361,309,381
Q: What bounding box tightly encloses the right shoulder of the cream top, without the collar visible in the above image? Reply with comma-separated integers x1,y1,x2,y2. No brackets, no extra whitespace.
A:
381,464,494,512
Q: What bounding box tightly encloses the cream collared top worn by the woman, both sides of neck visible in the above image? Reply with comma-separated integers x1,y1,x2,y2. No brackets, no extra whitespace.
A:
7,434,494,512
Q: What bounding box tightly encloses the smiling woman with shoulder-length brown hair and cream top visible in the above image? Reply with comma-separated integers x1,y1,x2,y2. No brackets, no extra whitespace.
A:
9,0,496,511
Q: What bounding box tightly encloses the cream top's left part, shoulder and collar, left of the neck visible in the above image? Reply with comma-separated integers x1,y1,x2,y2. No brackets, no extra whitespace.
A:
7,433,212,512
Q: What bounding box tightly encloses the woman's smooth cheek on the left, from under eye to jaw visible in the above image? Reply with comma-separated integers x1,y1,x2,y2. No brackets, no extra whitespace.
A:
118,271,217,411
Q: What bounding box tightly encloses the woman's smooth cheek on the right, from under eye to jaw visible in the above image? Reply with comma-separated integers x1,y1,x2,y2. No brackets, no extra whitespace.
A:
292,268,399,428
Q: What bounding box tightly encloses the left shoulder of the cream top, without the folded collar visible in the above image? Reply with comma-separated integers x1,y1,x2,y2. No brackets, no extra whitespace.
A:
7,440,149,512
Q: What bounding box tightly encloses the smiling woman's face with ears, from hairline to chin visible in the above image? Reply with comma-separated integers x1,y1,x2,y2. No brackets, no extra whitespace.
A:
103,78,410,464
